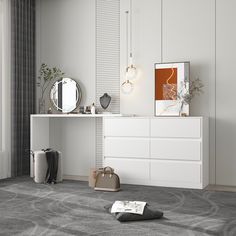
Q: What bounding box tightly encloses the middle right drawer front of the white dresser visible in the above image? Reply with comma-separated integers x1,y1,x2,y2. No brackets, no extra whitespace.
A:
151,139,201,161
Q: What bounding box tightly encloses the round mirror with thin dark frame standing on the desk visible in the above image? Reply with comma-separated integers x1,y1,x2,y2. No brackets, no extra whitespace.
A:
50,78,82,113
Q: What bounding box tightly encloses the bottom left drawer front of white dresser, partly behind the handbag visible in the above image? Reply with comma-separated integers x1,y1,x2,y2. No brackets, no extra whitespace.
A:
104,158,149,182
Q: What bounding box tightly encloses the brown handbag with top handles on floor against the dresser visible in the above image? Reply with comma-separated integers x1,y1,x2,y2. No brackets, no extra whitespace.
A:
94,166,120,192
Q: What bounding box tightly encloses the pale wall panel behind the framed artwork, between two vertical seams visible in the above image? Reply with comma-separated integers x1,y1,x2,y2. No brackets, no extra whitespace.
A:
162,0,215,183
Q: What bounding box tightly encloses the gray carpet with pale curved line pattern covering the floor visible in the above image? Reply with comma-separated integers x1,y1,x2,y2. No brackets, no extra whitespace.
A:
0,178,236,236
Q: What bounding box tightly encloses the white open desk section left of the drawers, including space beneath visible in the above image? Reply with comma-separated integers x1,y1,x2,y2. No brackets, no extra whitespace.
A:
30,114,122,180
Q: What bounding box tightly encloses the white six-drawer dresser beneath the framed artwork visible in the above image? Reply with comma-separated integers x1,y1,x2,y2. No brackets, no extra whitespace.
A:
103,117,209,189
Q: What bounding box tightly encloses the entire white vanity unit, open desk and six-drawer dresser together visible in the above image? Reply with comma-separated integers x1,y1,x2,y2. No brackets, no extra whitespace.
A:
31,114,209,189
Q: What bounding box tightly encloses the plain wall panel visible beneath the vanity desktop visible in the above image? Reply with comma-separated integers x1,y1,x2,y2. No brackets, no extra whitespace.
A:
50,118,96,176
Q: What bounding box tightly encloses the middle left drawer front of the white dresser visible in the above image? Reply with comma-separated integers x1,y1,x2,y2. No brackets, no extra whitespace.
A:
104,137,149,158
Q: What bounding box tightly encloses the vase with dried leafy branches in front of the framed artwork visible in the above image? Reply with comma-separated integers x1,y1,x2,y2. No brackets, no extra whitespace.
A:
177,77,204,116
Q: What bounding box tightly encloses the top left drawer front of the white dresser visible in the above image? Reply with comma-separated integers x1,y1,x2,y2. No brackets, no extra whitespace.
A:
104,117,149,137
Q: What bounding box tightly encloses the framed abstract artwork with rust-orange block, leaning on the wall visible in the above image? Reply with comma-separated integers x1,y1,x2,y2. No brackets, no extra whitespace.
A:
155,62,190,116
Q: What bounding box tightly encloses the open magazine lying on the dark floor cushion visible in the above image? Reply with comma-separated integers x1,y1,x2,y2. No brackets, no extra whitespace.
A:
111,201,147,215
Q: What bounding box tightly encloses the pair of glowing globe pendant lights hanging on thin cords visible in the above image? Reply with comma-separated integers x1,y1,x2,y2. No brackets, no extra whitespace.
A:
121,0,137,94
